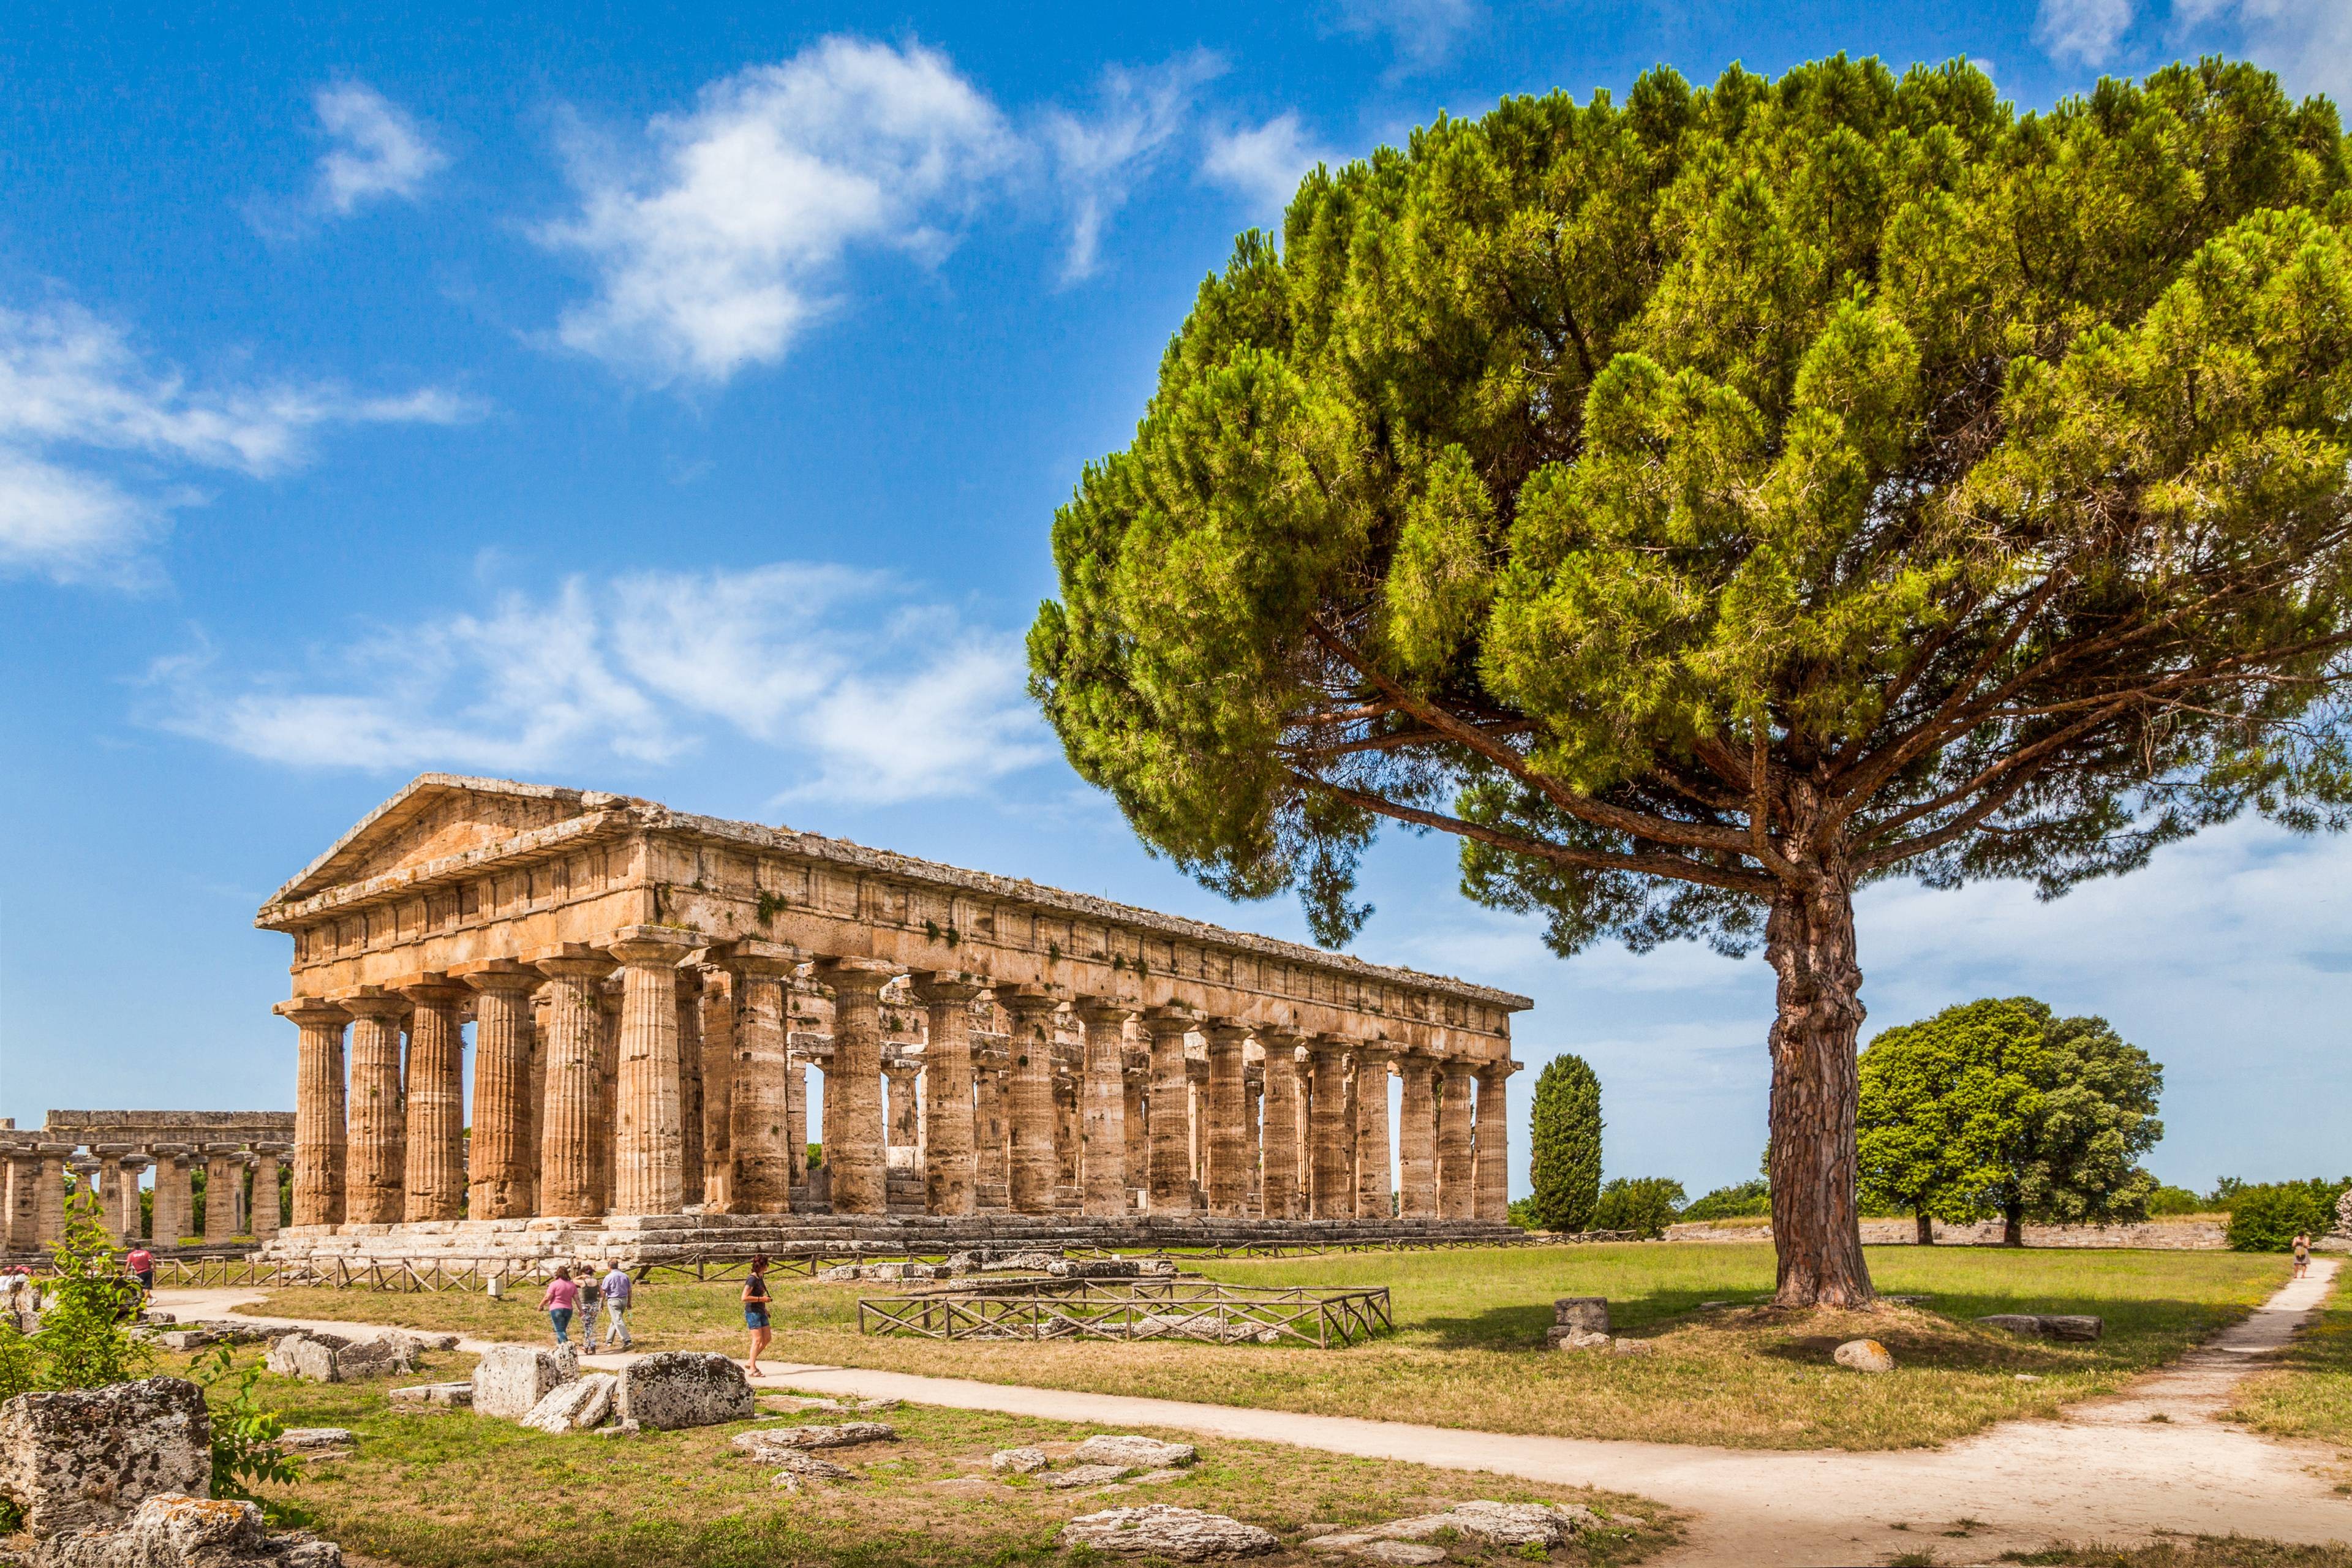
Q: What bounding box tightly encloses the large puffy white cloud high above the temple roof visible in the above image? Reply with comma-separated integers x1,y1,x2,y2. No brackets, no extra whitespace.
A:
543,37,1019,383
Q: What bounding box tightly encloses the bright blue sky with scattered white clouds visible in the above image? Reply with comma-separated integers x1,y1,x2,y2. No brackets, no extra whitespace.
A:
0,0,2352,1194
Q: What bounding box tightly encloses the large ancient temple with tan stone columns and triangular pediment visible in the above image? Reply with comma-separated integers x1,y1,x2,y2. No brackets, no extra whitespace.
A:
257,774,1529,1251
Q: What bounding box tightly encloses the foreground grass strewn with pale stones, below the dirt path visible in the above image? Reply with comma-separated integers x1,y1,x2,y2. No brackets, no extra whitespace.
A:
157,1352,1677,1568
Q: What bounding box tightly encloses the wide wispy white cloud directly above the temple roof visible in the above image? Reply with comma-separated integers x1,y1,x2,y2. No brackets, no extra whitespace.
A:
146,562,1051,804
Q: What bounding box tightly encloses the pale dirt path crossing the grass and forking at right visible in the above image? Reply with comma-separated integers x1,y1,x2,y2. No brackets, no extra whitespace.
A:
157,1260,2352,1568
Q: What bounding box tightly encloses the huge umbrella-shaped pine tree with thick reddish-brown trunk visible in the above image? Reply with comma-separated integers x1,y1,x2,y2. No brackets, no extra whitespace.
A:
1030,56,2352,1305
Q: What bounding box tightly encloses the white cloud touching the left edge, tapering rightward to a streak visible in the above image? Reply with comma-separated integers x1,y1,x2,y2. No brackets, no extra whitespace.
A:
0,303,478,586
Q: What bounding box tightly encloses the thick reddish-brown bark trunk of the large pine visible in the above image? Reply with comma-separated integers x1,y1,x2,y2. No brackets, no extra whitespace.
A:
1764,867,1877,1307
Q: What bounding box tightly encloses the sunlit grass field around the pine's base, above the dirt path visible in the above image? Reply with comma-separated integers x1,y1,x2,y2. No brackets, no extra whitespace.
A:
248,1243,2286,1448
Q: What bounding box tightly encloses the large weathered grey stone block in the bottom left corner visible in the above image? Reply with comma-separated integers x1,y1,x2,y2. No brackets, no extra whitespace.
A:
0,1378,212,1535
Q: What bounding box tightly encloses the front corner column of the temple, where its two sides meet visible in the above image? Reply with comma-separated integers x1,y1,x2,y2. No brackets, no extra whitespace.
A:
602,926,694,1215
